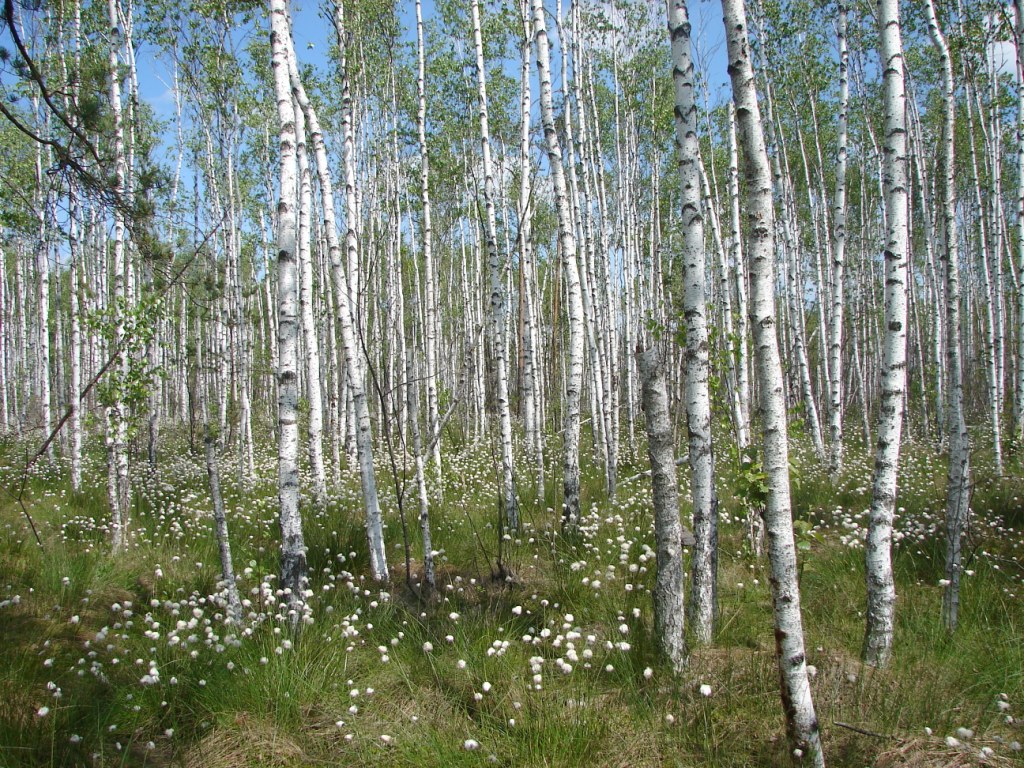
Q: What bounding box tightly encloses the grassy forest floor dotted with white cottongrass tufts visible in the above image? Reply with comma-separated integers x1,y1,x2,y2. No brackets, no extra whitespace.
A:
0,430,1024,768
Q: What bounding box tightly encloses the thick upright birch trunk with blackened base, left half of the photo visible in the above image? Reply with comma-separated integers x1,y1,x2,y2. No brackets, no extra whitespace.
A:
270,0,306,626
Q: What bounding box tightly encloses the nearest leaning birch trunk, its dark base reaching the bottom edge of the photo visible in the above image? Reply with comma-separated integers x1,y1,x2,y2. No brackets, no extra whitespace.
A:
722,0,824,768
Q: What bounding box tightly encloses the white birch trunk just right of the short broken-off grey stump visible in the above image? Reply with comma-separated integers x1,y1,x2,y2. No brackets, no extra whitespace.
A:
667,0,718,643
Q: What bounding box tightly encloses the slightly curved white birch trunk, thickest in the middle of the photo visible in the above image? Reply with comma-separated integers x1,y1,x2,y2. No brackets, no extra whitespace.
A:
532,0,585,528
